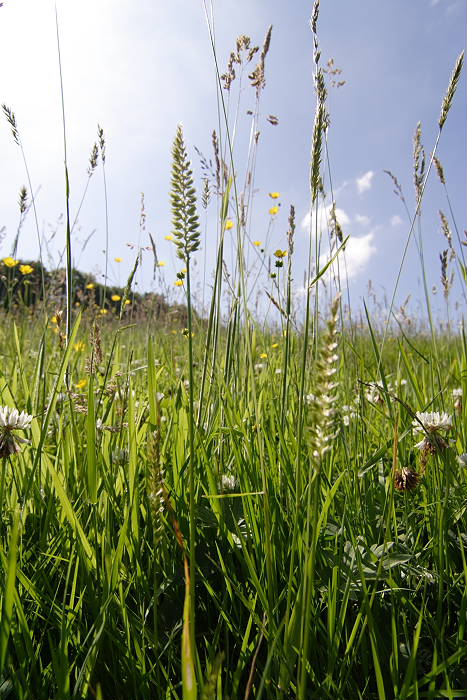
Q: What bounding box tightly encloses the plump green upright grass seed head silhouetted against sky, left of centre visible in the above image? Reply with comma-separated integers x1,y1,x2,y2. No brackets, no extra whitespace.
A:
170,124,200,263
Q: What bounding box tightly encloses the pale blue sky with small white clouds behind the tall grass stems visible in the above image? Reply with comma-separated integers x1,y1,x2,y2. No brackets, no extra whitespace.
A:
0,0,466,322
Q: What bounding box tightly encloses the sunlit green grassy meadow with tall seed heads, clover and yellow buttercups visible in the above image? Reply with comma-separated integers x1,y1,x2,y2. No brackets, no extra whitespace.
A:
0,3,467,700
